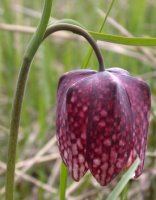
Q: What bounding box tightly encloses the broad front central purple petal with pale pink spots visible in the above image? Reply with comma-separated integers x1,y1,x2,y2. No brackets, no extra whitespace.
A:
87,72,133,185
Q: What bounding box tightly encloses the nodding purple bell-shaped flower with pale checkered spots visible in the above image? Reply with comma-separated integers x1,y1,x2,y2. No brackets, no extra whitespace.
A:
56,68,151,185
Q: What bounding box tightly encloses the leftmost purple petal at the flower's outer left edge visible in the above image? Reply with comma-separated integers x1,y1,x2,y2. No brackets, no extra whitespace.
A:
56,70,95,179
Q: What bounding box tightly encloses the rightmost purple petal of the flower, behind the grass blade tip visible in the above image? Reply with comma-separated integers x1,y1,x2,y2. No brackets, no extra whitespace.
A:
109,69,151,177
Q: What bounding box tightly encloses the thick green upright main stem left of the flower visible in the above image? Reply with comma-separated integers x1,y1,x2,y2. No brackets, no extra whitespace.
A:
5,0,52,200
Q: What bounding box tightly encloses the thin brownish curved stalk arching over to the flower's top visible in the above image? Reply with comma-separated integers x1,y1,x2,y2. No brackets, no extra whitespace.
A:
44,23,105,71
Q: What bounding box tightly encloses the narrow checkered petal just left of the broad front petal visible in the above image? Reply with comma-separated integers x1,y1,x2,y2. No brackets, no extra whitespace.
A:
67,76,92,181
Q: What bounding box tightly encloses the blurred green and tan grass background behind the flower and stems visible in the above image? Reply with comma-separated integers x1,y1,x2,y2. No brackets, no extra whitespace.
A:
0,0,156,200
